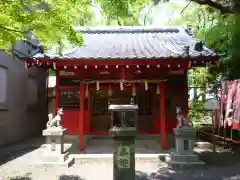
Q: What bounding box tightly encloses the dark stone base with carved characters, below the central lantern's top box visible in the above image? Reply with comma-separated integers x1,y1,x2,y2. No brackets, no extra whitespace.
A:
109,127,136,180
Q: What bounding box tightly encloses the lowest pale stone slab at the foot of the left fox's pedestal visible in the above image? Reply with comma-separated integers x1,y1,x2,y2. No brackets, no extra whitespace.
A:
35,156,75,168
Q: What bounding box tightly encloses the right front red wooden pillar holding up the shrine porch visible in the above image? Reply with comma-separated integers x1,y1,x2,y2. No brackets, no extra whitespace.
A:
159,82,167,149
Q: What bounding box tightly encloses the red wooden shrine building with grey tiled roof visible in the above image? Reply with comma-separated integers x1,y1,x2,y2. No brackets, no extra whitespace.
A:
25,27,218,149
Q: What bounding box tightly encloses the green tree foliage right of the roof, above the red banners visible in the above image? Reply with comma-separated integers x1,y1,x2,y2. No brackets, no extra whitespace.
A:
175,1,240,81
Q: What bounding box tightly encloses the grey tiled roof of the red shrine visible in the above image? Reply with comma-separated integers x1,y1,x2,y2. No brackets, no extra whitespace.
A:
35,27,216,59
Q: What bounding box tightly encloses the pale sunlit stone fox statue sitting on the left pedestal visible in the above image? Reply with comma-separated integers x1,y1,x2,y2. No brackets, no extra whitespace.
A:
47,108,63,128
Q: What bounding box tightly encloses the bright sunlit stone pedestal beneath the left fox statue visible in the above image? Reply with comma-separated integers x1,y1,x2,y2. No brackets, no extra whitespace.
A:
39,128,74,167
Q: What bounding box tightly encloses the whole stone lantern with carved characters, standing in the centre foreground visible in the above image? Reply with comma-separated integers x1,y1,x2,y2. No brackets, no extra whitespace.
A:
109,105,138,180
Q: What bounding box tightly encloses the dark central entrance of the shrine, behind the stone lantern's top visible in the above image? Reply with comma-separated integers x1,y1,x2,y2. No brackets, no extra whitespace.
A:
90,87,154,134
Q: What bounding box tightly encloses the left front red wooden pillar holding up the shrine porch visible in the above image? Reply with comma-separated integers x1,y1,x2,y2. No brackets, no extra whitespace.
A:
78,82,84,150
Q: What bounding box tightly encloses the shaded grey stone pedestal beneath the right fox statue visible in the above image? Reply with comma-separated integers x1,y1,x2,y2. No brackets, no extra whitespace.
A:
168,125,204,167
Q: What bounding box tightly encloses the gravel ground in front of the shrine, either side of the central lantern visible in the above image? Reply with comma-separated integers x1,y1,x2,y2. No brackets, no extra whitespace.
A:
0,149,240,180
